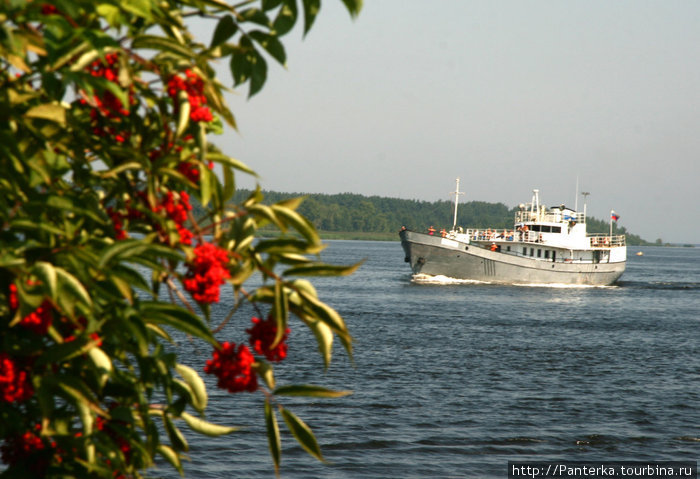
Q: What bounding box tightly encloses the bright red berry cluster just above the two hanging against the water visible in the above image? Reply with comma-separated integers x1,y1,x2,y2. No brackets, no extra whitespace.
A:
183,243,231,303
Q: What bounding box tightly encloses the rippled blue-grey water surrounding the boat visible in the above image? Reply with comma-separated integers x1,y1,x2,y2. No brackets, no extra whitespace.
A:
165,241,700,479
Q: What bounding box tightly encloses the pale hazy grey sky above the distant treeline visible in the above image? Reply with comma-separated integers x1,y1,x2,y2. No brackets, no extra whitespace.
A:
208,0,700,243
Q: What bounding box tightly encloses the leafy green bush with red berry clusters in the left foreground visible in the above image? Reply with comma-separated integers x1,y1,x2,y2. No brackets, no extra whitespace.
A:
0,0,361,478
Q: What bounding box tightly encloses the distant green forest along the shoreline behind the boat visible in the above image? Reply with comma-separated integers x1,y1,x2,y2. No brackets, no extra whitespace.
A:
220,190,650,245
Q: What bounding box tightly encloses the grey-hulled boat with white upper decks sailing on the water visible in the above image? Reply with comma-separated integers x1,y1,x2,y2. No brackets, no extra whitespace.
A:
399,178,627,286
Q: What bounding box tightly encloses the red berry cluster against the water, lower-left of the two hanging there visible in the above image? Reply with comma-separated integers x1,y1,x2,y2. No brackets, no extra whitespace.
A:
204,342,258,393
